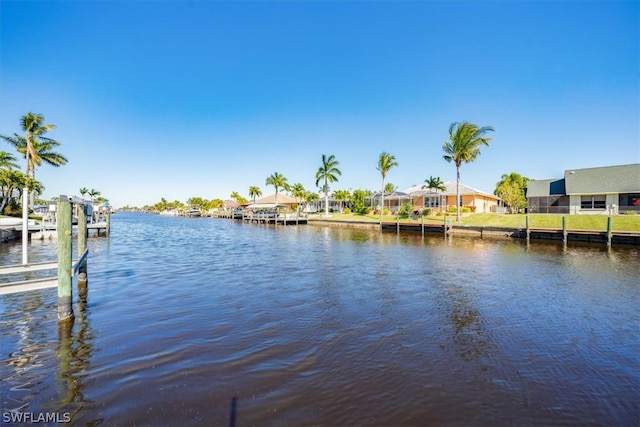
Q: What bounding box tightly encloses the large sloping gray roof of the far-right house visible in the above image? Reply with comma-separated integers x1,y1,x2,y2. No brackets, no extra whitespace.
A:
564,163,640,195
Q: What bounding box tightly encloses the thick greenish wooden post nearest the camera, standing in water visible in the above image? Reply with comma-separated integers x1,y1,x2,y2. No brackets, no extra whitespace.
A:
56,196,73,322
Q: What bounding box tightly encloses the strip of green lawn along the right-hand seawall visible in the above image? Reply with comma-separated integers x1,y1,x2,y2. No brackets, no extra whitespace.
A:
311,213,640,232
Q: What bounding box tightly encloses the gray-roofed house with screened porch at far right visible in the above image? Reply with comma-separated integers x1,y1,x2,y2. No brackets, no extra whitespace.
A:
527,163,640,215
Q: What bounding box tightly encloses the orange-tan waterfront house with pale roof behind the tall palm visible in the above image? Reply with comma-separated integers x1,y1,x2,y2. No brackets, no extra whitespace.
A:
404,181,500,213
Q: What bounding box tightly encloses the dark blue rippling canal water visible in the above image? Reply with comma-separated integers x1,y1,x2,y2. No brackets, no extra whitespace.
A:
0,213,640,426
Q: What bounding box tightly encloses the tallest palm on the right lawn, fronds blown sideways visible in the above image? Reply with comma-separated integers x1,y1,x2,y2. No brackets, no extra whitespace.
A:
442,122,494,221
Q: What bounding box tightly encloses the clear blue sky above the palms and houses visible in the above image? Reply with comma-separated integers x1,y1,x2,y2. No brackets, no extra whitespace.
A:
0,0,640,207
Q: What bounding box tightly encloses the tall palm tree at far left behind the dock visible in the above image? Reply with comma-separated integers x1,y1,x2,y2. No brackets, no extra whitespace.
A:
1,113,68,207
